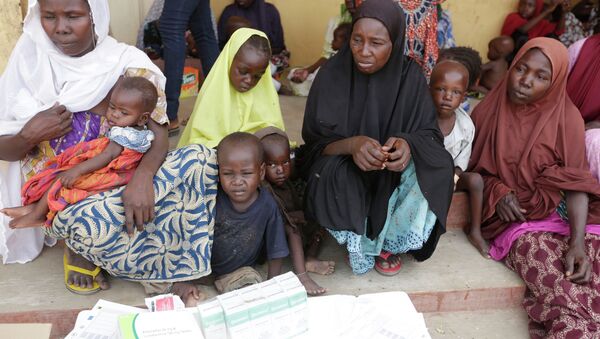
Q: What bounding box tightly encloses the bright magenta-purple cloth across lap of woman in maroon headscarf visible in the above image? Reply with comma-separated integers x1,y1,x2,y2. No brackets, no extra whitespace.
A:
489,212,600,260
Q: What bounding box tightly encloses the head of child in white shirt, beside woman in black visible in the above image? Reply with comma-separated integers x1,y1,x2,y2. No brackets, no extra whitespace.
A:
429,62,469,116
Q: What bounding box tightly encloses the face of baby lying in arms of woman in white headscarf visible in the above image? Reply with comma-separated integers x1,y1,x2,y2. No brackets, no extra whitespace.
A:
106,86,150,127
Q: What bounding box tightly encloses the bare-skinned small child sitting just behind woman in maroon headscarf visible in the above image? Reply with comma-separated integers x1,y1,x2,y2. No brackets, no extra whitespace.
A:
477,36,515,94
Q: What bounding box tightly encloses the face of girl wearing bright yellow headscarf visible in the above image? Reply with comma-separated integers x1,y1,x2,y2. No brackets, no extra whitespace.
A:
229,46,269,93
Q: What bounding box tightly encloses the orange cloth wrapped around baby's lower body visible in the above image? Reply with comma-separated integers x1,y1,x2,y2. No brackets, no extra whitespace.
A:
21,138,143,226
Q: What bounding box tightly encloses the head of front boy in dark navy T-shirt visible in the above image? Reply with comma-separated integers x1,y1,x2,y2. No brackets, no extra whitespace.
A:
219,145,265,206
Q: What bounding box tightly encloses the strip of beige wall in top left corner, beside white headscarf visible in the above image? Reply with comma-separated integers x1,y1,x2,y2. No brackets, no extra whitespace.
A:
0,0,22,72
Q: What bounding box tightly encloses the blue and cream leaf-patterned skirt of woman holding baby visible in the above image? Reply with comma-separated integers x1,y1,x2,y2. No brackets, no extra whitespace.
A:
46,145,218,282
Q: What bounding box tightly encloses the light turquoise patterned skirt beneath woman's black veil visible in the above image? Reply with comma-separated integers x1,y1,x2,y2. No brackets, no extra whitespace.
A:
328,161,436,274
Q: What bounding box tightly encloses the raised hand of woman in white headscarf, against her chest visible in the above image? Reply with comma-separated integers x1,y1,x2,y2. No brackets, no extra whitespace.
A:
19,103,73,145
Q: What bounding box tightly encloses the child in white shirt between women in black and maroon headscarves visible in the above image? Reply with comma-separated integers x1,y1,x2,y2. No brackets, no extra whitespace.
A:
429,60,489,258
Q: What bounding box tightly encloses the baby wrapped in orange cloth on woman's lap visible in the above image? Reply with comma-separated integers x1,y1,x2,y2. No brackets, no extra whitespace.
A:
1,77,158,228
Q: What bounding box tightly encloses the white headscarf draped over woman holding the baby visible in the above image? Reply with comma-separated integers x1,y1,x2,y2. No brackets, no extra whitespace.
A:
0,0,164,135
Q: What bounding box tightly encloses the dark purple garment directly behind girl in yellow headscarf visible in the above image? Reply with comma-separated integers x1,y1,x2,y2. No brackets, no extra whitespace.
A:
218,0,285,54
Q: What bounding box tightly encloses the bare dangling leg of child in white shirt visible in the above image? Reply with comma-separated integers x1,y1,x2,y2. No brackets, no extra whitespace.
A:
456,172,491,259
